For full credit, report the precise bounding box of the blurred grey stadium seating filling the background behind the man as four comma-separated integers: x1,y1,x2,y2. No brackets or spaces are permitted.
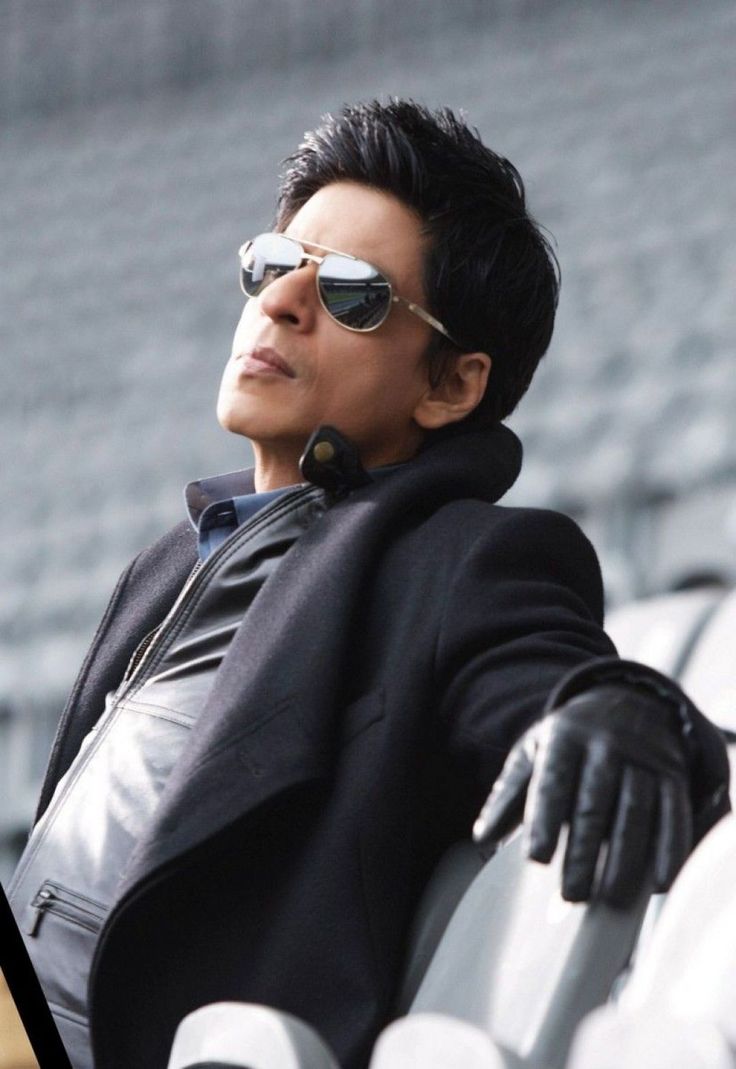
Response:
0,0,736,879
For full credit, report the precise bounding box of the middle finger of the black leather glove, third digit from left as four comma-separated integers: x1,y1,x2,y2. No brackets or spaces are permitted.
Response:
563,741,620,902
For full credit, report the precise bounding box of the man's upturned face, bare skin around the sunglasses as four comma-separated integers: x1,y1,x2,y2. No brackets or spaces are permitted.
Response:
217,182,431,481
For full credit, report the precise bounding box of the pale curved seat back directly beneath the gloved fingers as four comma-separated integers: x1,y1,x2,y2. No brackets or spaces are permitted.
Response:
402,833,648,1069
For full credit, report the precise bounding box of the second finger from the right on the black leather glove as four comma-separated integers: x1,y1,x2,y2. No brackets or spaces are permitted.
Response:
598,765,658,908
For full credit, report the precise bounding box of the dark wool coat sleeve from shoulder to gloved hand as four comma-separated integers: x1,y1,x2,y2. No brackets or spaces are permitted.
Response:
435,509,616,804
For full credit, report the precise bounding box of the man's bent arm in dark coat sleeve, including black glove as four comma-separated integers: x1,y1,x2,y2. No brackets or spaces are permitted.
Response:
438,510,729,904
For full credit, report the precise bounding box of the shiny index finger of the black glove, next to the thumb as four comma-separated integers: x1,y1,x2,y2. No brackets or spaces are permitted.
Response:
524,718,583,863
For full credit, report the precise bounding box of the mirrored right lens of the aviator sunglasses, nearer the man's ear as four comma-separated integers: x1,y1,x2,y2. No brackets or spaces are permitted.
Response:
317,253,392,330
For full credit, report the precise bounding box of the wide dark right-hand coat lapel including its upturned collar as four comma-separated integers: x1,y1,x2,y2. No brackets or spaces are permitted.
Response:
121,428,520,896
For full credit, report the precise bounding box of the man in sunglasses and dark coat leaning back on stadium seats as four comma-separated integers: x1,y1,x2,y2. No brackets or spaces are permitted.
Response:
7,100,726,1069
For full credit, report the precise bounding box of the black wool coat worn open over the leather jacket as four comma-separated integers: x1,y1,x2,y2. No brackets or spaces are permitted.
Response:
35,427,615,1069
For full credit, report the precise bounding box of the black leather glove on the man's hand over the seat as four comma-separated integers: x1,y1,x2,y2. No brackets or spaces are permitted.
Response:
473,662,729,907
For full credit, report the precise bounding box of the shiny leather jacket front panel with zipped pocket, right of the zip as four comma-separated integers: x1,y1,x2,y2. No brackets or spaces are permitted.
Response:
9,486,326,1069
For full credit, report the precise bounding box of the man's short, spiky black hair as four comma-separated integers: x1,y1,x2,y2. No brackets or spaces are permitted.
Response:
277,98,559,424
